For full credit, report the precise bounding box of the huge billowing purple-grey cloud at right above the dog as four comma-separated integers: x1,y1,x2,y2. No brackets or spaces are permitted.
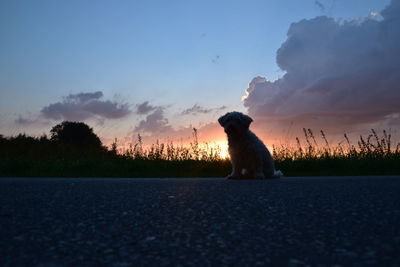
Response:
243,0,400,134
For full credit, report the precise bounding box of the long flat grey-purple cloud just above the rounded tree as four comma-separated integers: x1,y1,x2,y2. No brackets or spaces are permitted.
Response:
41,91,131,121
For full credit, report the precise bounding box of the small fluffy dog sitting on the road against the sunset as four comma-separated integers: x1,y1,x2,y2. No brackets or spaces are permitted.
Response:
218,111,283,179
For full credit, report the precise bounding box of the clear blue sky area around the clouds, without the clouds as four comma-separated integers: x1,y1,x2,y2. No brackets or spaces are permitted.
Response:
0,0,389,144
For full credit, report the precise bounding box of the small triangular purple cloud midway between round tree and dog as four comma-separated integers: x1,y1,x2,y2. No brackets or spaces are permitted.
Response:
135,108,173,135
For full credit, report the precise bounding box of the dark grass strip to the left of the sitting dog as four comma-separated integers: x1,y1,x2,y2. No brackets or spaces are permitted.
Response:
0,131,230,177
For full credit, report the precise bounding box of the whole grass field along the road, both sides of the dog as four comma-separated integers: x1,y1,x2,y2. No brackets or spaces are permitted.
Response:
0,129,400,177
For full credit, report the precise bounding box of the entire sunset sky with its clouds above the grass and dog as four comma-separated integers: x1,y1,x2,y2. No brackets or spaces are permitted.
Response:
0,0,400,151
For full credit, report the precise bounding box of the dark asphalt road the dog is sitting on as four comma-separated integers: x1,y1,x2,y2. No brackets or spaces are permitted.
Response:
0,177,400,266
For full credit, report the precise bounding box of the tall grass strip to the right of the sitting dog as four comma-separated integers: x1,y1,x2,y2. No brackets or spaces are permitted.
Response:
273,129,400,175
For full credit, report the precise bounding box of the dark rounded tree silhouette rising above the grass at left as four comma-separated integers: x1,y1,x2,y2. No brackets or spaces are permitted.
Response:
50,121,102,149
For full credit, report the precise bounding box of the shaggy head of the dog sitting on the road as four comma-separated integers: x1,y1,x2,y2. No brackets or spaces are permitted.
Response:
218,111,253,135
